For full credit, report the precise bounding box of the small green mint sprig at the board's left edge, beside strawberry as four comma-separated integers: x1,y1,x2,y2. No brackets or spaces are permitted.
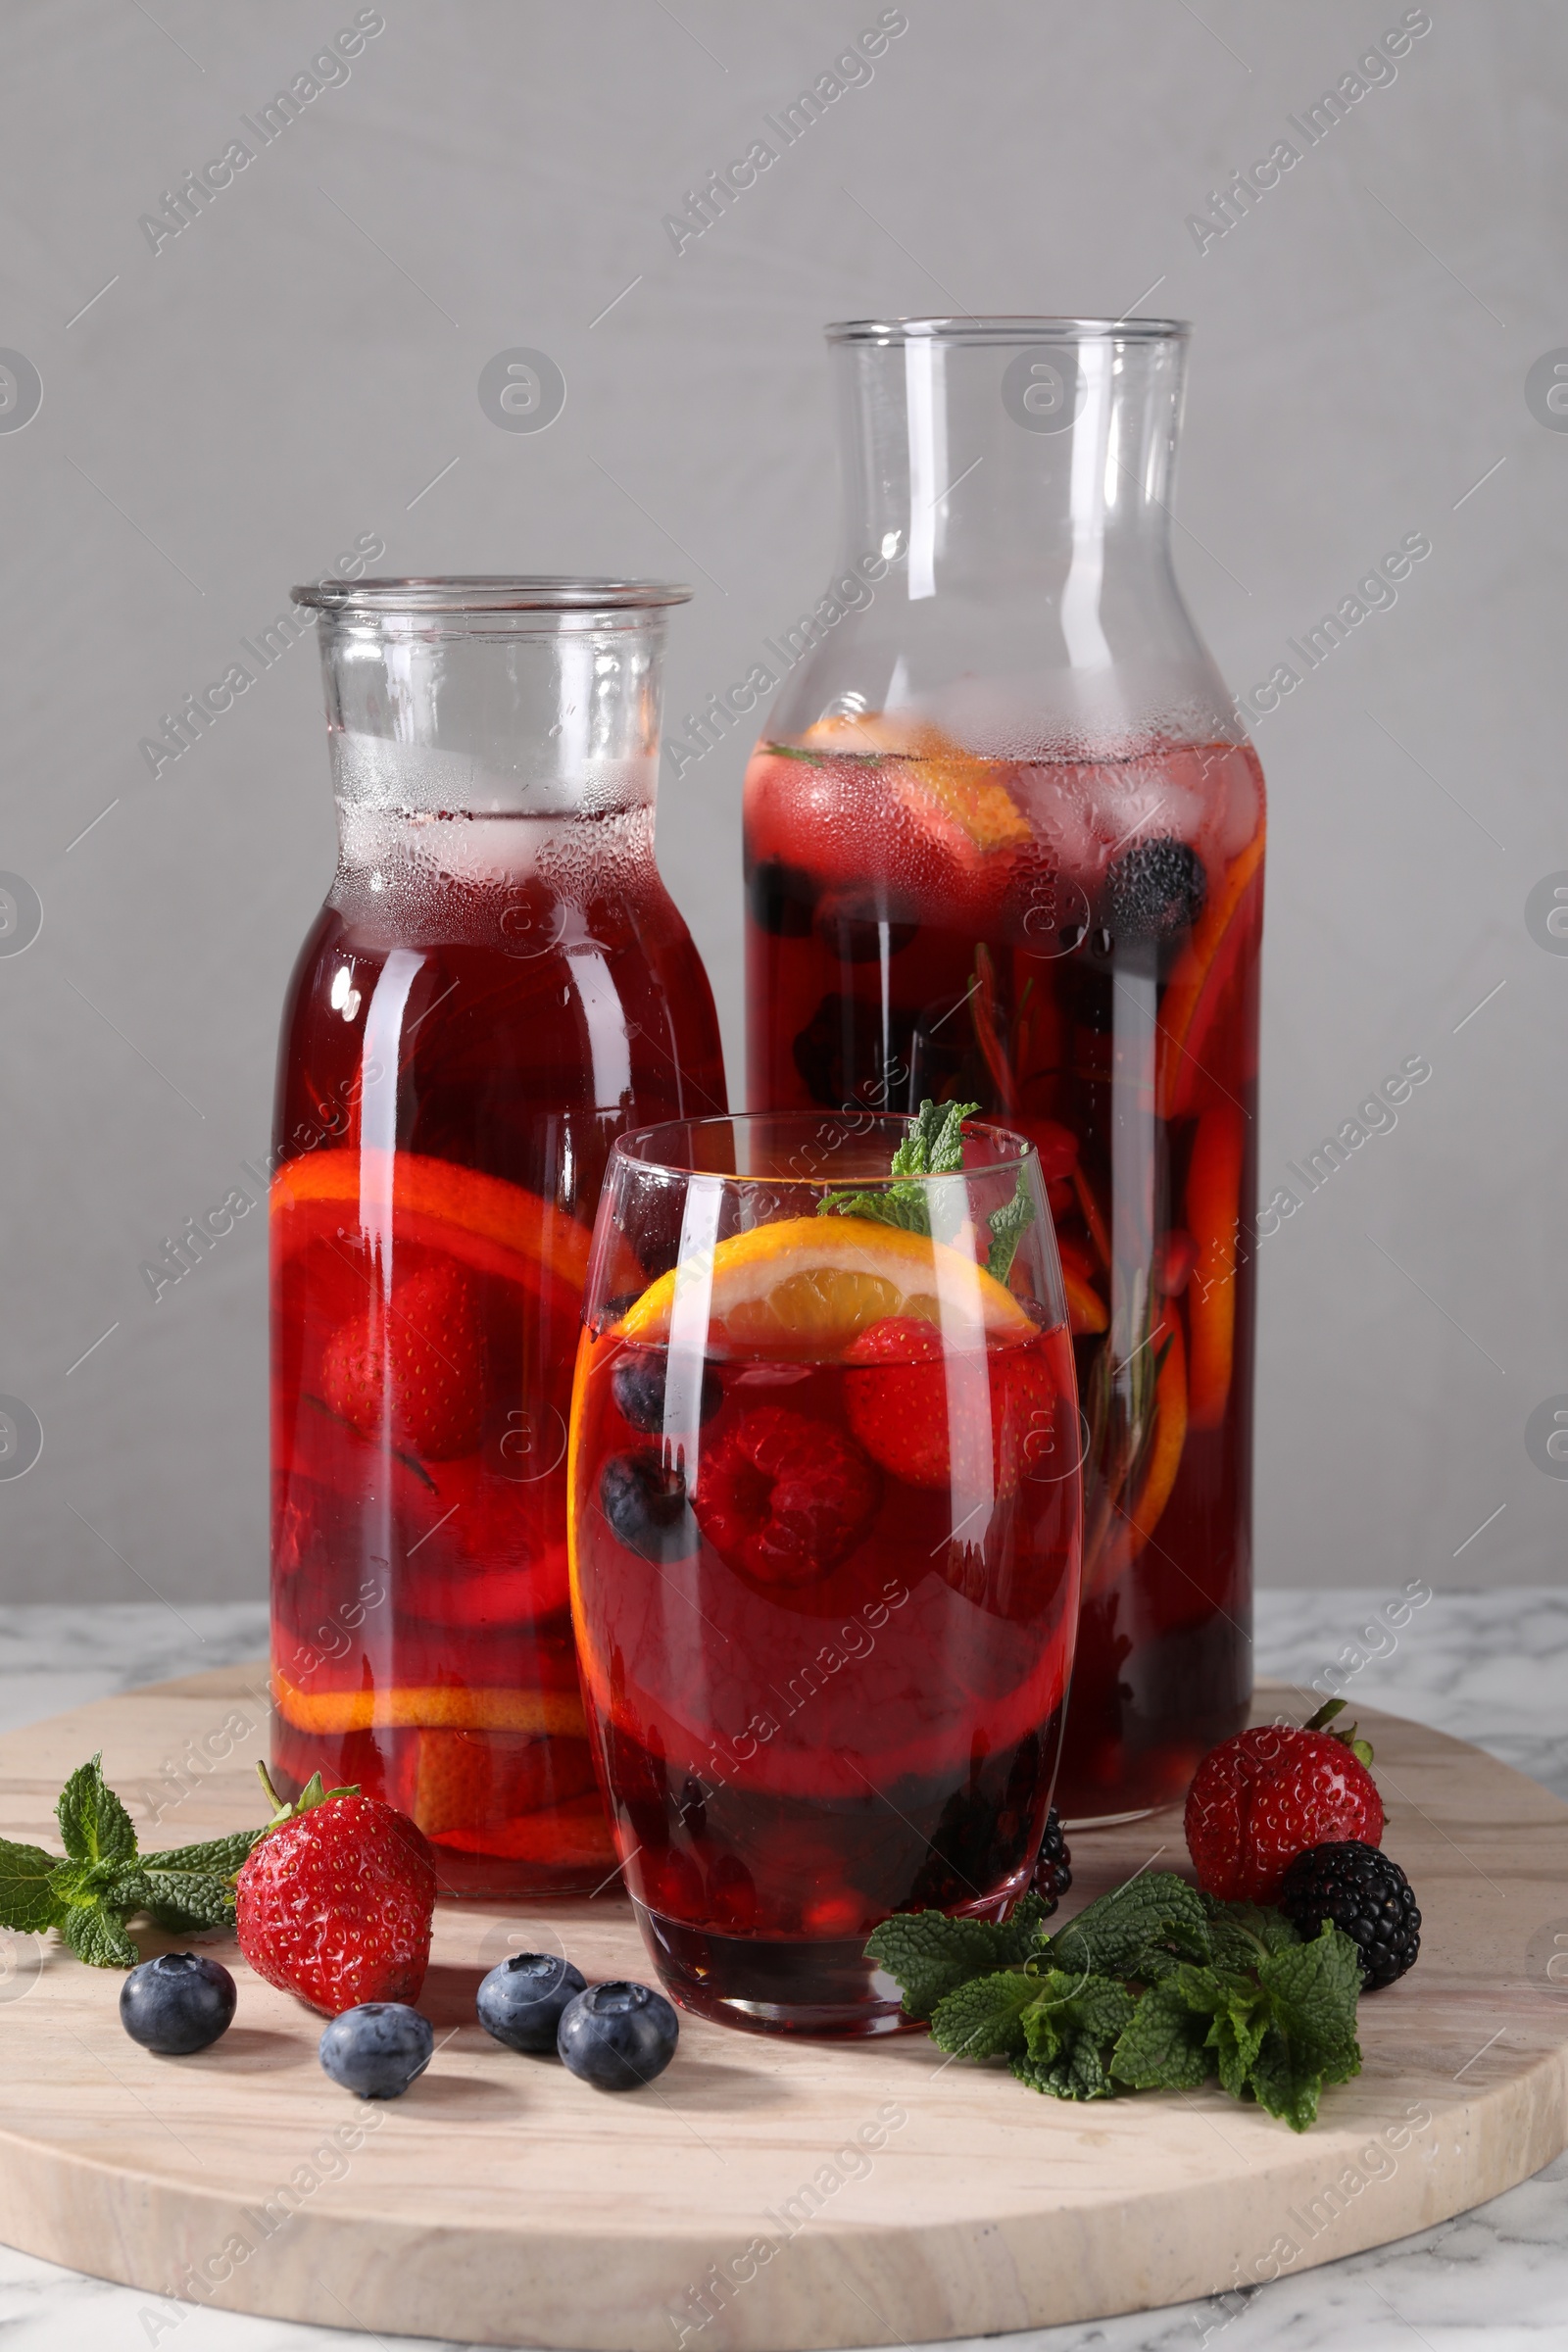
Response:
0,1754,266,1969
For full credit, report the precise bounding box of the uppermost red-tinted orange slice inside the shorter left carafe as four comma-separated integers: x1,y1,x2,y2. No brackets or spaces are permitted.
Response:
270,1148,590,1294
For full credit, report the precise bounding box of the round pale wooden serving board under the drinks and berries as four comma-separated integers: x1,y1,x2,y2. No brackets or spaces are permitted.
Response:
0,1668,1568,2352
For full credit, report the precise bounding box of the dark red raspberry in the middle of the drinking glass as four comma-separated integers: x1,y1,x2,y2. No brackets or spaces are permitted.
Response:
691,1404,882,1586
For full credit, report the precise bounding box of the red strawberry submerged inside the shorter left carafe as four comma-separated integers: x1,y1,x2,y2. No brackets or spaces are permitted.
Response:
322,1258,484,1463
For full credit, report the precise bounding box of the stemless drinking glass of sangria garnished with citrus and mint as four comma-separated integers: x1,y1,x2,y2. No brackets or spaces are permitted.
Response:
571,1105,1081,2034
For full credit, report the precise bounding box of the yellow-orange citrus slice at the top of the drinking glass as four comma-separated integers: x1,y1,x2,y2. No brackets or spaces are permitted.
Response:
620,1216,1034,1354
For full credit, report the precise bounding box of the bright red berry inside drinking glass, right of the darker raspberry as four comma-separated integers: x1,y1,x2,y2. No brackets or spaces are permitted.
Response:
844,1315,1057,1494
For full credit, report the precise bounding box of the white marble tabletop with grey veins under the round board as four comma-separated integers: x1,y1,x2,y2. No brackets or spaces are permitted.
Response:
0,1590,1568,2352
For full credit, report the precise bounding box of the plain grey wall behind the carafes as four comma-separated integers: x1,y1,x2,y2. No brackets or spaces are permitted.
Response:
0,0,1568,1601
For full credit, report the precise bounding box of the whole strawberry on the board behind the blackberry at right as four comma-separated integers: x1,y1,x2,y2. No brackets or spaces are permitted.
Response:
1187,1698,1382,1903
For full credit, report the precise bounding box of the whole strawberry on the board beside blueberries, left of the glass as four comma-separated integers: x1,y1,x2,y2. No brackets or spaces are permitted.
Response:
235,1764,435,2018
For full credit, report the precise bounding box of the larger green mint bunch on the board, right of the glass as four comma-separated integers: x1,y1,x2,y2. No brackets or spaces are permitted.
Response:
865,1870,1361,2131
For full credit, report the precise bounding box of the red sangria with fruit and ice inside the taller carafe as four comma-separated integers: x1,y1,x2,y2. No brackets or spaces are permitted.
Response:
748,719,1262,1818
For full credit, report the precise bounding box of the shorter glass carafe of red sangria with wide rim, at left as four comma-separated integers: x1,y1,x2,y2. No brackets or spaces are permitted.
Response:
270,578,724,1893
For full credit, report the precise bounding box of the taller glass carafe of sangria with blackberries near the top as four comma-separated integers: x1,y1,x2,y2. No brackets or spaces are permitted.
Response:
745,318,1265,1821
